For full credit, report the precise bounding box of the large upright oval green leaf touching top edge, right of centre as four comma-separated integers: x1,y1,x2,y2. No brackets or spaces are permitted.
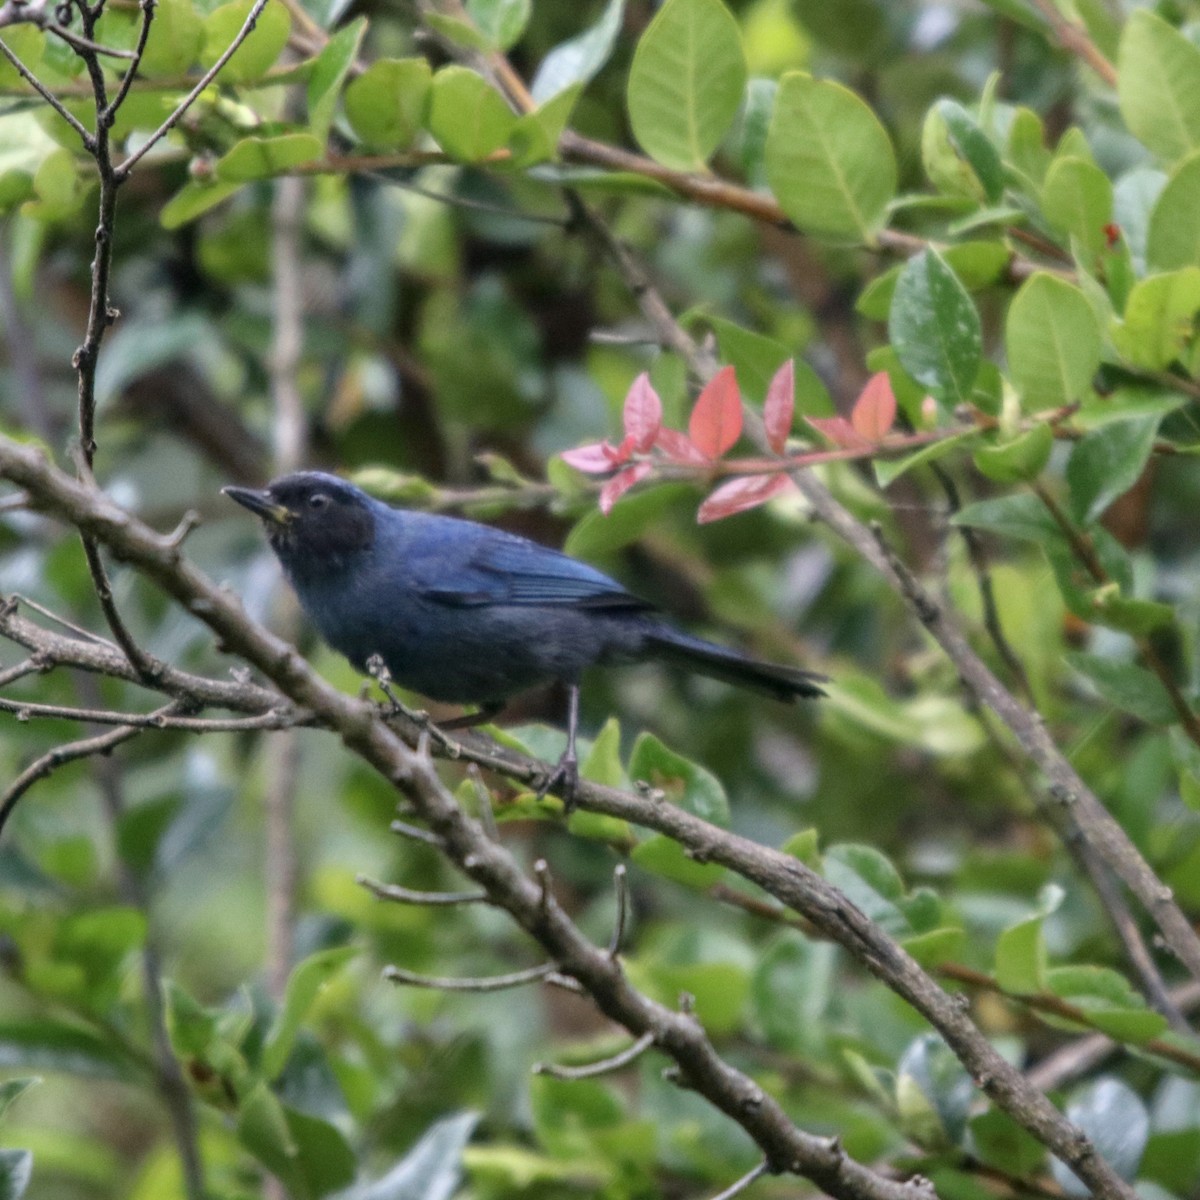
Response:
626,0,746,170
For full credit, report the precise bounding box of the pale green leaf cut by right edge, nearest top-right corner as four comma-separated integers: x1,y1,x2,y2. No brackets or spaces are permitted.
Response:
1117,8,1200,162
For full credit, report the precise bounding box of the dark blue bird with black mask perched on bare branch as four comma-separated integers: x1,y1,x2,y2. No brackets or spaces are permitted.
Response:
224,472,823,805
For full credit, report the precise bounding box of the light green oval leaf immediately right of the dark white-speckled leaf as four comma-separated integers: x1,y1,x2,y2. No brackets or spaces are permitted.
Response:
1004,271,1102,412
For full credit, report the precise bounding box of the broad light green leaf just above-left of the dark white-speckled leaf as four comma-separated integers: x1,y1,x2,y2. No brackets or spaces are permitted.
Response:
767,71,896,242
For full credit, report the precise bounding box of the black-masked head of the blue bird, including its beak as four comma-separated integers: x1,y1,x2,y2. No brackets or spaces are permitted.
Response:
222,470,374,574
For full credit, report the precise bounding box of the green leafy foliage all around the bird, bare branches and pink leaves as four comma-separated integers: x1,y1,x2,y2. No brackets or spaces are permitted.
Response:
0,0,1200,1200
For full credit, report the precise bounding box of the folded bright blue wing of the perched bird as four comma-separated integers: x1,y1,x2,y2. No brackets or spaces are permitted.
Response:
412,529,653,612
